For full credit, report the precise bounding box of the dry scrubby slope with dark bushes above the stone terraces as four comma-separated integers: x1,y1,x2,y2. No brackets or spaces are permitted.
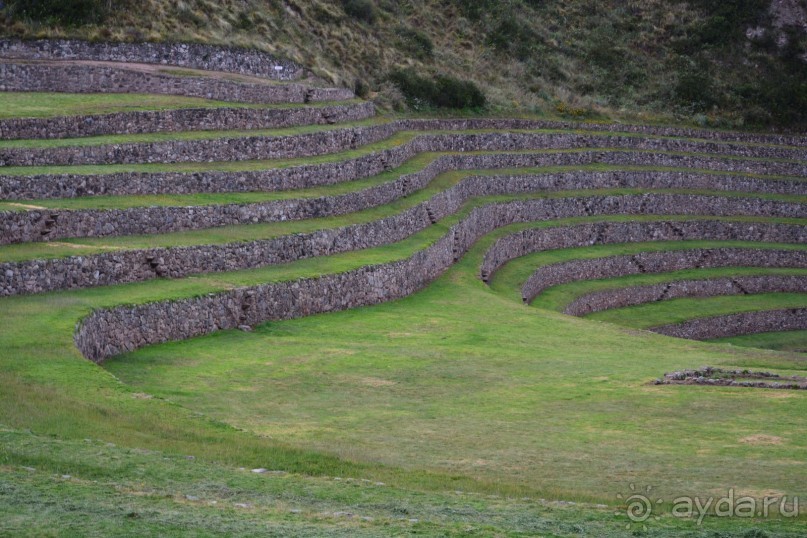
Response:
0,0,807,127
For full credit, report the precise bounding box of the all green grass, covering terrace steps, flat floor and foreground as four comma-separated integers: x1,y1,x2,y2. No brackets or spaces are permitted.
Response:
0,86,807,538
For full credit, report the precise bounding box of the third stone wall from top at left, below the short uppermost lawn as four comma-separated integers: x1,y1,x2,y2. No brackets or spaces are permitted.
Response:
0,101,375,140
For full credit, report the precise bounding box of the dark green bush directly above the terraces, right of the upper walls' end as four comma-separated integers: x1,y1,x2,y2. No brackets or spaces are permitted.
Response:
389,69,487,109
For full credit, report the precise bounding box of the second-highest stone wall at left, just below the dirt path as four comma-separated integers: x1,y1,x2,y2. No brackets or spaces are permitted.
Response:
0,58,355,107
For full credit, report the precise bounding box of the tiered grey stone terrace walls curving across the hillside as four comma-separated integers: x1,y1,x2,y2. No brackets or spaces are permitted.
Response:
0,41,807,362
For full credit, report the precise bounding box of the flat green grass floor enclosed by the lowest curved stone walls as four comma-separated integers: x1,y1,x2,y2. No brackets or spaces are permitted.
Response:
101,231,807,502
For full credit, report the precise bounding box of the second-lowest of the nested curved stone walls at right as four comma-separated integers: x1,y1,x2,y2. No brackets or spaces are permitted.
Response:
563,275,807,316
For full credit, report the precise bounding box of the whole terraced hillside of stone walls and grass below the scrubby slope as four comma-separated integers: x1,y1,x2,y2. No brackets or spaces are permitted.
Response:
0,42,807,536
